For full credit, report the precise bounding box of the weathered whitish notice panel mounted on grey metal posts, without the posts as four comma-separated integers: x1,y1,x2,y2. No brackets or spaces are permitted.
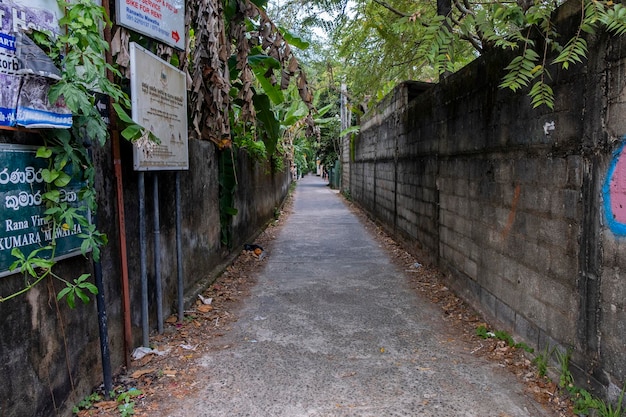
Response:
130,42,189,171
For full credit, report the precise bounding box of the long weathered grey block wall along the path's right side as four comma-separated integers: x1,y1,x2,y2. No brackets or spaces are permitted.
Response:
343,3,626,396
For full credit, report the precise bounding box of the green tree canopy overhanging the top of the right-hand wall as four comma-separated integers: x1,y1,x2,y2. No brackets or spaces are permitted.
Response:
275,0,626,107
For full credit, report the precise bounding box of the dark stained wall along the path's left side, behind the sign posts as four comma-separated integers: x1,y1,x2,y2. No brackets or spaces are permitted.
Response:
0,135,290,417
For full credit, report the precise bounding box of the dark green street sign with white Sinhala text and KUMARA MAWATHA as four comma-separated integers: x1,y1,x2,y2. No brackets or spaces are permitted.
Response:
0,145,84,277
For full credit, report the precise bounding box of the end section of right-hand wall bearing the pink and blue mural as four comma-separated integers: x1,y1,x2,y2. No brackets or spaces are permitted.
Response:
596,33,626,391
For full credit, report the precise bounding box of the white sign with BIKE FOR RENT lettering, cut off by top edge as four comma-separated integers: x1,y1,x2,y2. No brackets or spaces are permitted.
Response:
115,0,185,49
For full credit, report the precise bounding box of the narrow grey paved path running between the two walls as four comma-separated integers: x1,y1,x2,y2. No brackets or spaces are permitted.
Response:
164,176,551,417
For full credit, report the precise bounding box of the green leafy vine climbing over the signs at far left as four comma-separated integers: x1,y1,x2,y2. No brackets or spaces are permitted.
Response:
0,0,147,308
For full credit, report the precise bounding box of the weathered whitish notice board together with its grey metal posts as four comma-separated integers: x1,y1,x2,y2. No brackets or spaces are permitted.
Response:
130,42,189,346
